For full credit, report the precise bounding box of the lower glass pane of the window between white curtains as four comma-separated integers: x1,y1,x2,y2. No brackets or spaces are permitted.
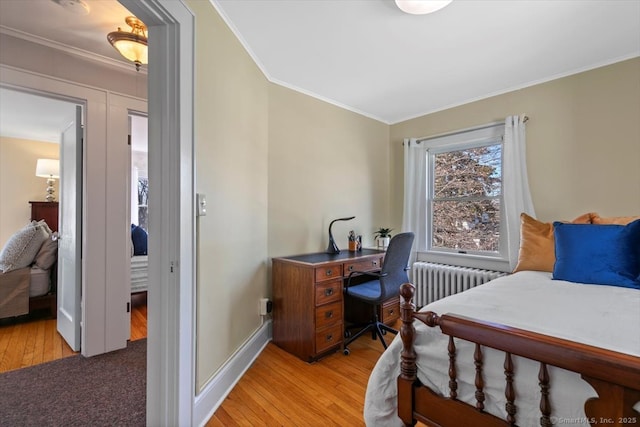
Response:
432,199,500,252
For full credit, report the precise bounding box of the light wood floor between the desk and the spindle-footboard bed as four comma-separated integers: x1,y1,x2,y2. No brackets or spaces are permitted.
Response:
206,324,394,427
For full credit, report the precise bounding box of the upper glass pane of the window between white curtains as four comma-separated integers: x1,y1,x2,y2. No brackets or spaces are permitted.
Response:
433,144,502,199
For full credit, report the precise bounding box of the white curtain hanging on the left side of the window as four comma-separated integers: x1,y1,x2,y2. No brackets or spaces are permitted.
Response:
402,138,428,263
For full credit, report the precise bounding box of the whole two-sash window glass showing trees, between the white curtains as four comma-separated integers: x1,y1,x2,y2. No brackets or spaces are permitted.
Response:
427,138,503,256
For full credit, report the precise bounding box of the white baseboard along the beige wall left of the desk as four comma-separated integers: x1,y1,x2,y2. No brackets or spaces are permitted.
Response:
193,319,272,427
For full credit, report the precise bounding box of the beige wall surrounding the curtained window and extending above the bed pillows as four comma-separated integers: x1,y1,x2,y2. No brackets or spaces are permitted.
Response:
389,58,640,225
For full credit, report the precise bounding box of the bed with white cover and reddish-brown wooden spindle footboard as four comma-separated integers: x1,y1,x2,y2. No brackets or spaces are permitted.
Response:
364,216,640,427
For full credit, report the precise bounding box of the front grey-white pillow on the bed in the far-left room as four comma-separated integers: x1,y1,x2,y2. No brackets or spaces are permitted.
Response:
0,224,49,273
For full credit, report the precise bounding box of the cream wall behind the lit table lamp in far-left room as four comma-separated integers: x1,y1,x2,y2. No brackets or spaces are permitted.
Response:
0,138,60,248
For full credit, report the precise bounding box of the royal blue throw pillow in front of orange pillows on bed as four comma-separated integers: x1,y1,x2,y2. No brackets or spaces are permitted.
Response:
553,220,640,289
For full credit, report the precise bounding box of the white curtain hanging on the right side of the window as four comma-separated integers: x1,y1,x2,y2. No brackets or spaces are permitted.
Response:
502,115,535,270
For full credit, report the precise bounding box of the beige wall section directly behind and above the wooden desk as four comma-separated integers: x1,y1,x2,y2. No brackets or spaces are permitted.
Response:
269,84,390,257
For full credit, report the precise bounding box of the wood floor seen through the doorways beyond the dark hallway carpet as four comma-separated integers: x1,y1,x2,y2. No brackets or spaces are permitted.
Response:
0,294,147,373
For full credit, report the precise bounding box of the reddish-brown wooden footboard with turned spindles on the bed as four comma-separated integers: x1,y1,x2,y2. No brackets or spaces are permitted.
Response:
398,283,640,427
